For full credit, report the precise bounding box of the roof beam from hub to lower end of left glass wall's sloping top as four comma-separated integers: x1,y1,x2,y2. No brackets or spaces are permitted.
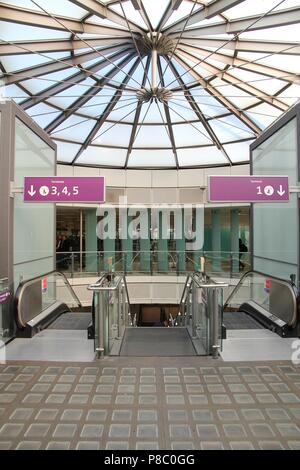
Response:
45,53,135,134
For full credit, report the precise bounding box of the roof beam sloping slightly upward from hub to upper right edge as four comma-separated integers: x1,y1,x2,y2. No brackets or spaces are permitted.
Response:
167,7,300,38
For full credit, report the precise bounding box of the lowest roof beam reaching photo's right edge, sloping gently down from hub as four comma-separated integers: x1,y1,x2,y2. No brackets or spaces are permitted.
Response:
181,44,300,82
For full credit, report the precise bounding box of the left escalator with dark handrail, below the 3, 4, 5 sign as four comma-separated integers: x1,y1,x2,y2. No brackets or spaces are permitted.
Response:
14,271,85,338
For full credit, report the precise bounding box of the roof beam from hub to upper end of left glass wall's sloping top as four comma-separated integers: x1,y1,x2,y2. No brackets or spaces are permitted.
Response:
21,49,132,109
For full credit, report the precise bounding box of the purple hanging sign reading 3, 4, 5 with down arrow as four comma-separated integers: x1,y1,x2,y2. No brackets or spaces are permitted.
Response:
24,176,105,203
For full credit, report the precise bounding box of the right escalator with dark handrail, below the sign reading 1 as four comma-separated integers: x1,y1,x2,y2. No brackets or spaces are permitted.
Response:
223,271,300,338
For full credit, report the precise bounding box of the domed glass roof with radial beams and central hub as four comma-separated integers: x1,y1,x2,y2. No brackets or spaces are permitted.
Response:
0,0,300,168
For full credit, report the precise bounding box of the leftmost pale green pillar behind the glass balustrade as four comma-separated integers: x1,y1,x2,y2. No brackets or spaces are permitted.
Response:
85,209,98,273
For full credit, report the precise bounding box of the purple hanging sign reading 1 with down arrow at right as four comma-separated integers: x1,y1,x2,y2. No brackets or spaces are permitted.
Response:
208,175,289,202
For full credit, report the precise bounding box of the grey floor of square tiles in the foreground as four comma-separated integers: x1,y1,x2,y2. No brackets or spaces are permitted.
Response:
0,357,300,450
